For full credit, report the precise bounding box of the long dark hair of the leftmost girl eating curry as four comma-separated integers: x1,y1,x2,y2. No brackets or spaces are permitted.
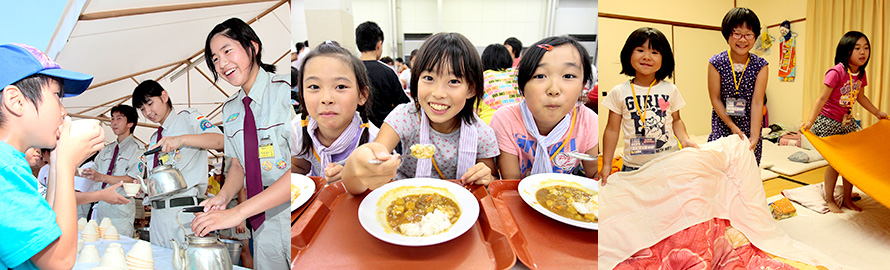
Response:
297,43,372,156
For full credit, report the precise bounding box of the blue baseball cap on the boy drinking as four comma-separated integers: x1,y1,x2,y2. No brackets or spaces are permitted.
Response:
0,43,93,97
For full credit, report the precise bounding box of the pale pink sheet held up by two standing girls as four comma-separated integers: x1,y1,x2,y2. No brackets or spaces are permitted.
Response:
598,136,844,269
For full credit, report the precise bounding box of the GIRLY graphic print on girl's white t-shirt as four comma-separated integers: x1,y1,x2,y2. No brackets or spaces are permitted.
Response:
624,94,671,148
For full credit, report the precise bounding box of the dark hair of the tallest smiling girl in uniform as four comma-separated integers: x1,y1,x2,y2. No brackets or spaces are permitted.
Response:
204,18,275,82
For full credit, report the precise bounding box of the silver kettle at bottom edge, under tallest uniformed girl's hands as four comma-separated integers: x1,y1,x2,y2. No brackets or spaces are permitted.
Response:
170,206,232,270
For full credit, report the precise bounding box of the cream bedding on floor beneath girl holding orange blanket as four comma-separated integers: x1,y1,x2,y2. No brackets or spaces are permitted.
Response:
767,189,890,269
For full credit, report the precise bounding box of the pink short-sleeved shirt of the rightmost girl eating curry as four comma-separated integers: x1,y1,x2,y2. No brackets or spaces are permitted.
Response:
491,104,599,177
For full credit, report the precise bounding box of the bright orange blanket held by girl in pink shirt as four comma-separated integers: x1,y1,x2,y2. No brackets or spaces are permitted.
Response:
800,120,890,207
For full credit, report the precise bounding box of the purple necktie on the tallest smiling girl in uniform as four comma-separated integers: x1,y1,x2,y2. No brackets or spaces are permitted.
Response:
241,97,266,230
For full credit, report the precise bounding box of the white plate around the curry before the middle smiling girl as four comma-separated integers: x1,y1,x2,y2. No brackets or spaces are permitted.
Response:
358,178,479,246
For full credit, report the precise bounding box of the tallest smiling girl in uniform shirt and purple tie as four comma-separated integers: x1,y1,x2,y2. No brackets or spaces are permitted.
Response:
191,18,294,269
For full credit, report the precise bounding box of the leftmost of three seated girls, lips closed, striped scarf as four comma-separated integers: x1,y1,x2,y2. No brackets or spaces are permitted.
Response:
291,43,378,182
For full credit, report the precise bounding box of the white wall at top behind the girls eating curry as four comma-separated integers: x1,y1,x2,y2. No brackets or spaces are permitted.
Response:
352,0,597,56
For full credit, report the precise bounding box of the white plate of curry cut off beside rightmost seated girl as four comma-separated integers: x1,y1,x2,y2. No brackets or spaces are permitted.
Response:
518,173,599,230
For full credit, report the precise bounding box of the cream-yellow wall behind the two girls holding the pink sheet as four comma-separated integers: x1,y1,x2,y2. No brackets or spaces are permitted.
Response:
599,0,812,142
